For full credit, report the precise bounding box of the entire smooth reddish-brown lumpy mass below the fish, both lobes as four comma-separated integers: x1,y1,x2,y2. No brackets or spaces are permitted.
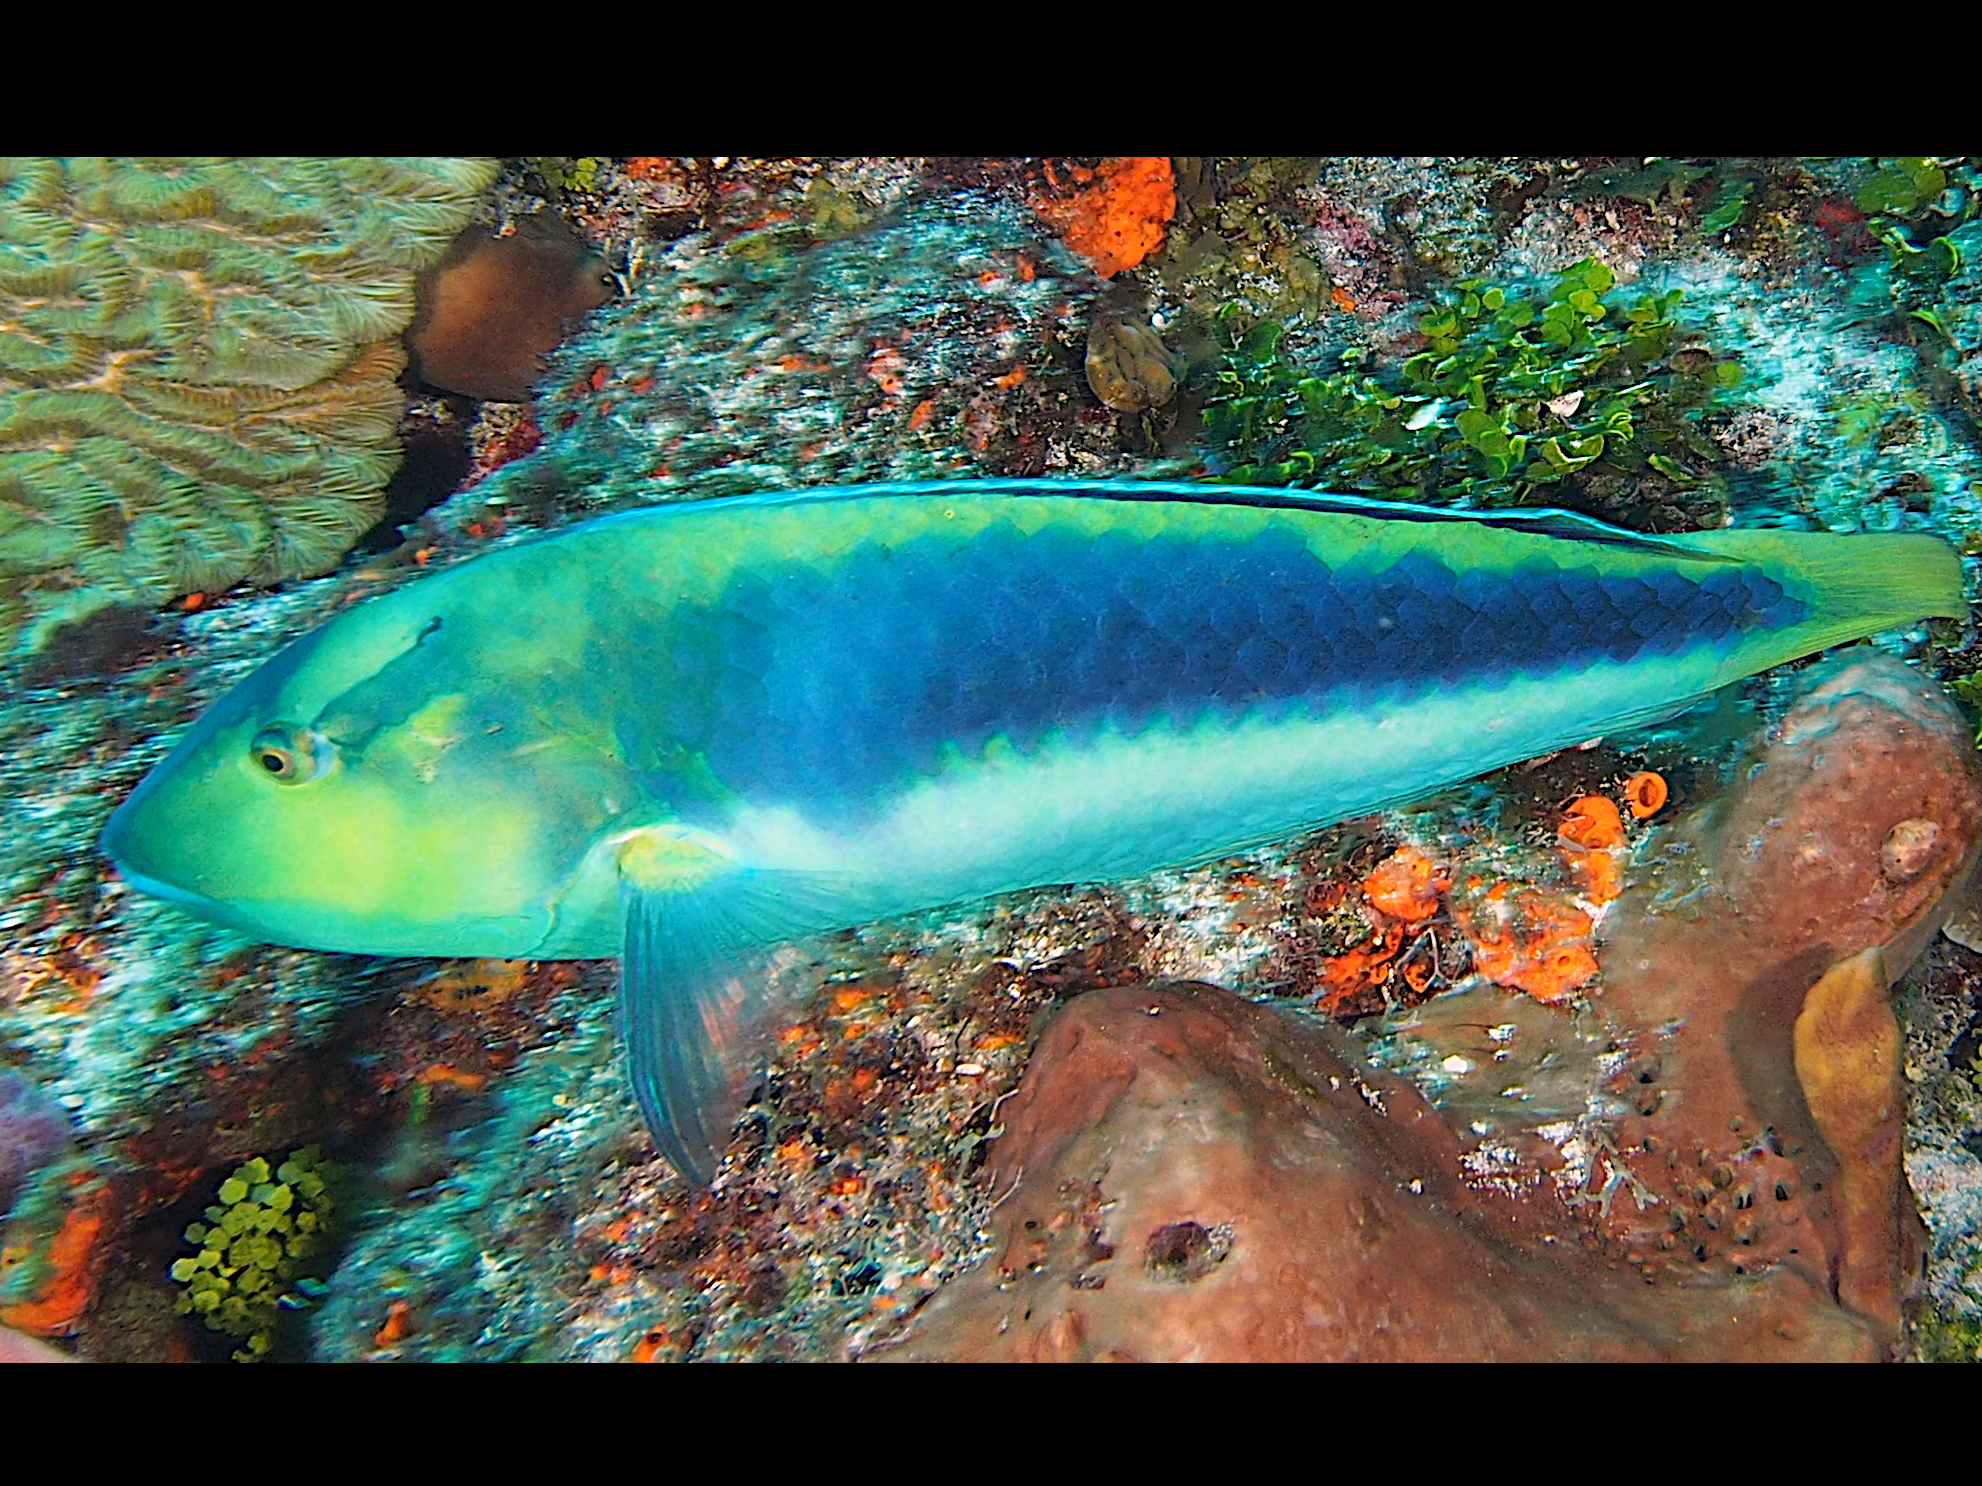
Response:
892,652,1982,1361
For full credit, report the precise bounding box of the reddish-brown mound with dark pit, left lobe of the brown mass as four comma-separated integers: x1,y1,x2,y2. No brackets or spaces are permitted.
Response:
894,985,1875,1361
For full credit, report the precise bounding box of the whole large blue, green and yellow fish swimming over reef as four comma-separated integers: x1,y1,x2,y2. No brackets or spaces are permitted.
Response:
103,479,1966,1181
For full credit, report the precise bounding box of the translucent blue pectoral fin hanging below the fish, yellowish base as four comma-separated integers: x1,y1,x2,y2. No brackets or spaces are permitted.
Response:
618,828,838,1187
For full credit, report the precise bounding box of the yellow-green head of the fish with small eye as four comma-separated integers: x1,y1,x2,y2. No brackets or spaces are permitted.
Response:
103,575,614,957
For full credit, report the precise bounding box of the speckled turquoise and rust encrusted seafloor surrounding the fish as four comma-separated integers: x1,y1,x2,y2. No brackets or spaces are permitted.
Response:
0,159,1982,1361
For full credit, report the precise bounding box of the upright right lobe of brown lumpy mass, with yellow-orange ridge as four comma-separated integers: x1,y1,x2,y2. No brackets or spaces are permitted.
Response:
1569,652,1982,1337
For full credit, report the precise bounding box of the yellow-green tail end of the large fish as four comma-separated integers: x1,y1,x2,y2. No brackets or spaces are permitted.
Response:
1677,531,1968,680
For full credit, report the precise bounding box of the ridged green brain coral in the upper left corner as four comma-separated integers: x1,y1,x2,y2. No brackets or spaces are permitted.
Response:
0,160,496,654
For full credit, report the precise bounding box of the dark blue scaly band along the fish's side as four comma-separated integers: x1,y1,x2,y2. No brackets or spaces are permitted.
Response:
668,527,1808,818
